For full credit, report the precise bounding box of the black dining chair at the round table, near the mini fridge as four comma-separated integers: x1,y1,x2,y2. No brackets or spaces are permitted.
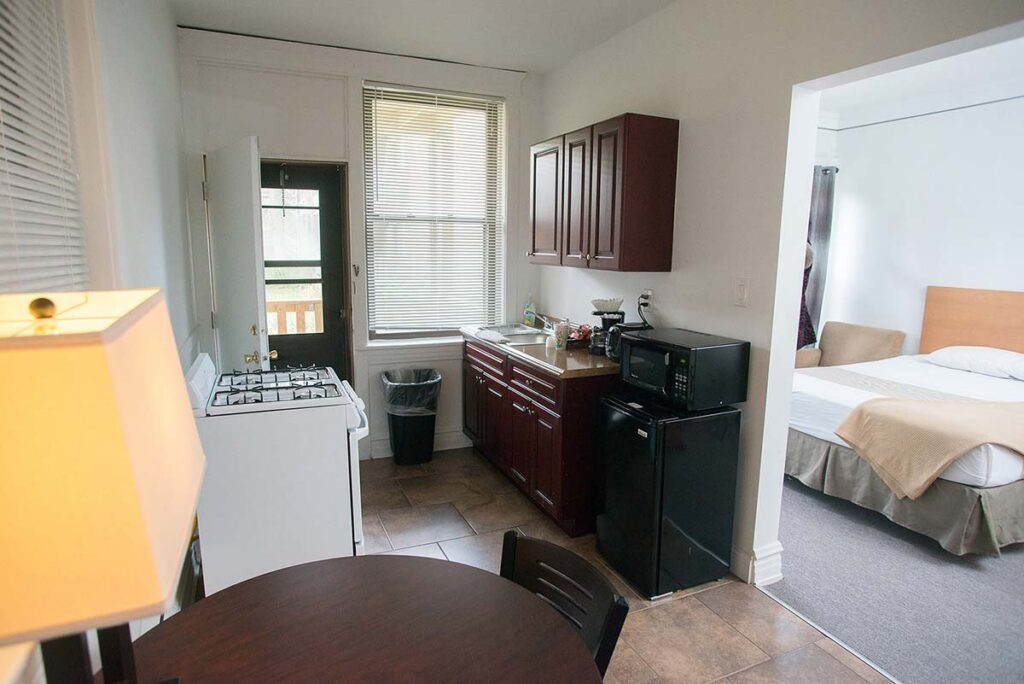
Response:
501,529,630,677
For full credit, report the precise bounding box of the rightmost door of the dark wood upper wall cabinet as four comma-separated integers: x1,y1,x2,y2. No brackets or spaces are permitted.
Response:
590,117,626,268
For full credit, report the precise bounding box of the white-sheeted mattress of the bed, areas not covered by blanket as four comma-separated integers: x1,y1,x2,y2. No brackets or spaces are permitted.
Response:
790,355,1024,487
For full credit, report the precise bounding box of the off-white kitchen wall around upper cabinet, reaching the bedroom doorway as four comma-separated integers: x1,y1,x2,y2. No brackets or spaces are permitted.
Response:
520,0,1024,582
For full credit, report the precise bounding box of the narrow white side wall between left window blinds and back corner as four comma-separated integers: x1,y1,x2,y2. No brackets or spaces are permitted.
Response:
95,0,197,366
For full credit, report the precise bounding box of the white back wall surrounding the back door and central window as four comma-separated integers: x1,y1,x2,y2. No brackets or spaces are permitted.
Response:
178,29,527,457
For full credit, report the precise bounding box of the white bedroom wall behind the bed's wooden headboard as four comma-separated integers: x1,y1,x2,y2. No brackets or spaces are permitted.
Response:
822,96,1024,353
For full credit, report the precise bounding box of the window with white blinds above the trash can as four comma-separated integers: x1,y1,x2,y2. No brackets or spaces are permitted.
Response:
362,85,505,338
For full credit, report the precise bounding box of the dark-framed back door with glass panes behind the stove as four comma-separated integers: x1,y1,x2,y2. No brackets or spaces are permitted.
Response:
260,161,351,380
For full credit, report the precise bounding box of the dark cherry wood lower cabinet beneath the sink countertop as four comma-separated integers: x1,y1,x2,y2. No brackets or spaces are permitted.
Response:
463,340,614,536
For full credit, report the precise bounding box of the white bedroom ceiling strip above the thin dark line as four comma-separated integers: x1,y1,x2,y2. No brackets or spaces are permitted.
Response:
821,39,1024,126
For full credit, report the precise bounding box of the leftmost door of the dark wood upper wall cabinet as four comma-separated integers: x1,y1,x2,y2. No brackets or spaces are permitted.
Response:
529,137,562,263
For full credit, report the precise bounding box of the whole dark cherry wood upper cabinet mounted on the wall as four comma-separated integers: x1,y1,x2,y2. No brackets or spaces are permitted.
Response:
530,114,679,271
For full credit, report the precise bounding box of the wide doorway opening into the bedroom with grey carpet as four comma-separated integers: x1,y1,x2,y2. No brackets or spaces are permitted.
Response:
763,25,1024,682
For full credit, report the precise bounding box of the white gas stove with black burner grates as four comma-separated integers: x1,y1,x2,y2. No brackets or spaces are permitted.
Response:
187,354,369,594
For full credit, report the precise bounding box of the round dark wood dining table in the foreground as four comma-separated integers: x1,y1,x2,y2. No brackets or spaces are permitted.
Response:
134,556,601,684
